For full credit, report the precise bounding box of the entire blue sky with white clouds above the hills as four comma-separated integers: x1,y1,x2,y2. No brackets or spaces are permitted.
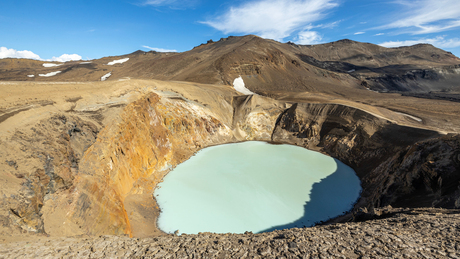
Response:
0,0,460,61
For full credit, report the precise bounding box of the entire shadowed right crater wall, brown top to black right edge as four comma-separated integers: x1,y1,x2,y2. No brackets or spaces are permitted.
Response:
272,104,460,220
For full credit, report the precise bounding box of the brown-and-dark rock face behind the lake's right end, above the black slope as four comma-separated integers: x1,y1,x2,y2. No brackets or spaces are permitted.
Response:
272,103,439,177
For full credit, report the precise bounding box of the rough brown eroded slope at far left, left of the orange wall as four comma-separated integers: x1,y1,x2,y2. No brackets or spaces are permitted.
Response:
1,115,99,232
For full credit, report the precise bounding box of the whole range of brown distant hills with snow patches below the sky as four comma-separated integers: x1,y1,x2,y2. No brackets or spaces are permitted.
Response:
0,35,460,98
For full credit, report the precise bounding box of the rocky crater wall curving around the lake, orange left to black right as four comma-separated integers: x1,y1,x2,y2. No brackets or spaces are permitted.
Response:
2,88,460,237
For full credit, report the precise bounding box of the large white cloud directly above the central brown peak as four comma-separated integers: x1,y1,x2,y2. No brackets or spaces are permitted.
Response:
202,0,338,40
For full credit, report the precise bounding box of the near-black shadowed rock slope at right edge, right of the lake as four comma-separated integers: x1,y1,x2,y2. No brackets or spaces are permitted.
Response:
363,135,460,208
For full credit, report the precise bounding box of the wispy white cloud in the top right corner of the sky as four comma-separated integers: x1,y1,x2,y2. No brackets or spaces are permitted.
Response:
379,0,460,34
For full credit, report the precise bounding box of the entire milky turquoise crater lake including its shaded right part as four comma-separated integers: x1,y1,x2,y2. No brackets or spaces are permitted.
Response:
154,141,361,234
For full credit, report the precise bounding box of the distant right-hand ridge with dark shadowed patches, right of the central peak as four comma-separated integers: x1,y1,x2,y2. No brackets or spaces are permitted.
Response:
296,40,460,96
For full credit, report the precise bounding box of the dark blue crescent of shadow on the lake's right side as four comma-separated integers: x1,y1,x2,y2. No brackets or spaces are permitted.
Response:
260,159,361,232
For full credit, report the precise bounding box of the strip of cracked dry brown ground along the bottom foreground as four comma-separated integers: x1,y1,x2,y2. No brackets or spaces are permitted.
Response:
0,209,460,258
